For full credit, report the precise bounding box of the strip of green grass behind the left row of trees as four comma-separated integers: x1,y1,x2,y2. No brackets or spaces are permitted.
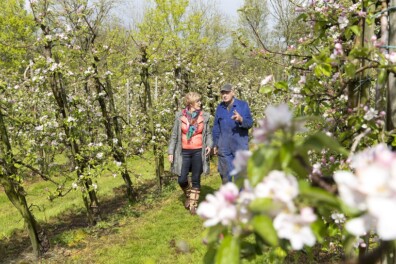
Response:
0,154,155,240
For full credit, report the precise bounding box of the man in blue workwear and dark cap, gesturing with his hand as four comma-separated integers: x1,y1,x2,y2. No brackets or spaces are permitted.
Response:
212,84,253,184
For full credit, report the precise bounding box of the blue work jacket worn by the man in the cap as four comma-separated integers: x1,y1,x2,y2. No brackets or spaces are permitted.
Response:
212,98,253,154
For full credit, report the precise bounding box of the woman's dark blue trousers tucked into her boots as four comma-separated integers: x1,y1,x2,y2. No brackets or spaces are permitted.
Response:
177,149,203,189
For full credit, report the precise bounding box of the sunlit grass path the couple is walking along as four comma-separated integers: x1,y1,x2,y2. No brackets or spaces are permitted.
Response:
45,176,220,263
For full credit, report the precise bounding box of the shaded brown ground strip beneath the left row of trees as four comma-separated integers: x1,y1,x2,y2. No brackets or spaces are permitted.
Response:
0,175,177,263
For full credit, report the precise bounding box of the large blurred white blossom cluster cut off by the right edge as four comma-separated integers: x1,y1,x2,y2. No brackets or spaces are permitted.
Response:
334,144,396,240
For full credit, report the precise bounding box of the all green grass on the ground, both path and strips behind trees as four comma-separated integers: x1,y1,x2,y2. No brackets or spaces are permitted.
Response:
0,155,276,264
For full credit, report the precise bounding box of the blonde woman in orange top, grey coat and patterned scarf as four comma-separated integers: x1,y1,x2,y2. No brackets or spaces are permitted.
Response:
168,92,212,214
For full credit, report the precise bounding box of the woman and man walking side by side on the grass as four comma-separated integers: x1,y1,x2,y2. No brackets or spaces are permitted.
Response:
168,84,253,214
